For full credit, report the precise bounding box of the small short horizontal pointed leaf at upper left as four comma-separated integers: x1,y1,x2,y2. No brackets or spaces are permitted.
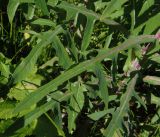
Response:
31,18,56,27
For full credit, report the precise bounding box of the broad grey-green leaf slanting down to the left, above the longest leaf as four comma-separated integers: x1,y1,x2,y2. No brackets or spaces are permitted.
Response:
13,26,62,83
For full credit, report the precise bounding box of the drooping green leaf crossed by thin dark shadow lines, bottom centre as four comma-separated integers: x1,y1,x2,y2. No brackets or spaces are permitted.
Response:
67,82,86,133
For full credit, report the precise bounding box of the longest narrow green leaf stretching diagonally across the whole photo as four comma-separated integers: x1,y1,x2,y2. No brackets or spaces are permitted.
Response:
15,35,155,113
